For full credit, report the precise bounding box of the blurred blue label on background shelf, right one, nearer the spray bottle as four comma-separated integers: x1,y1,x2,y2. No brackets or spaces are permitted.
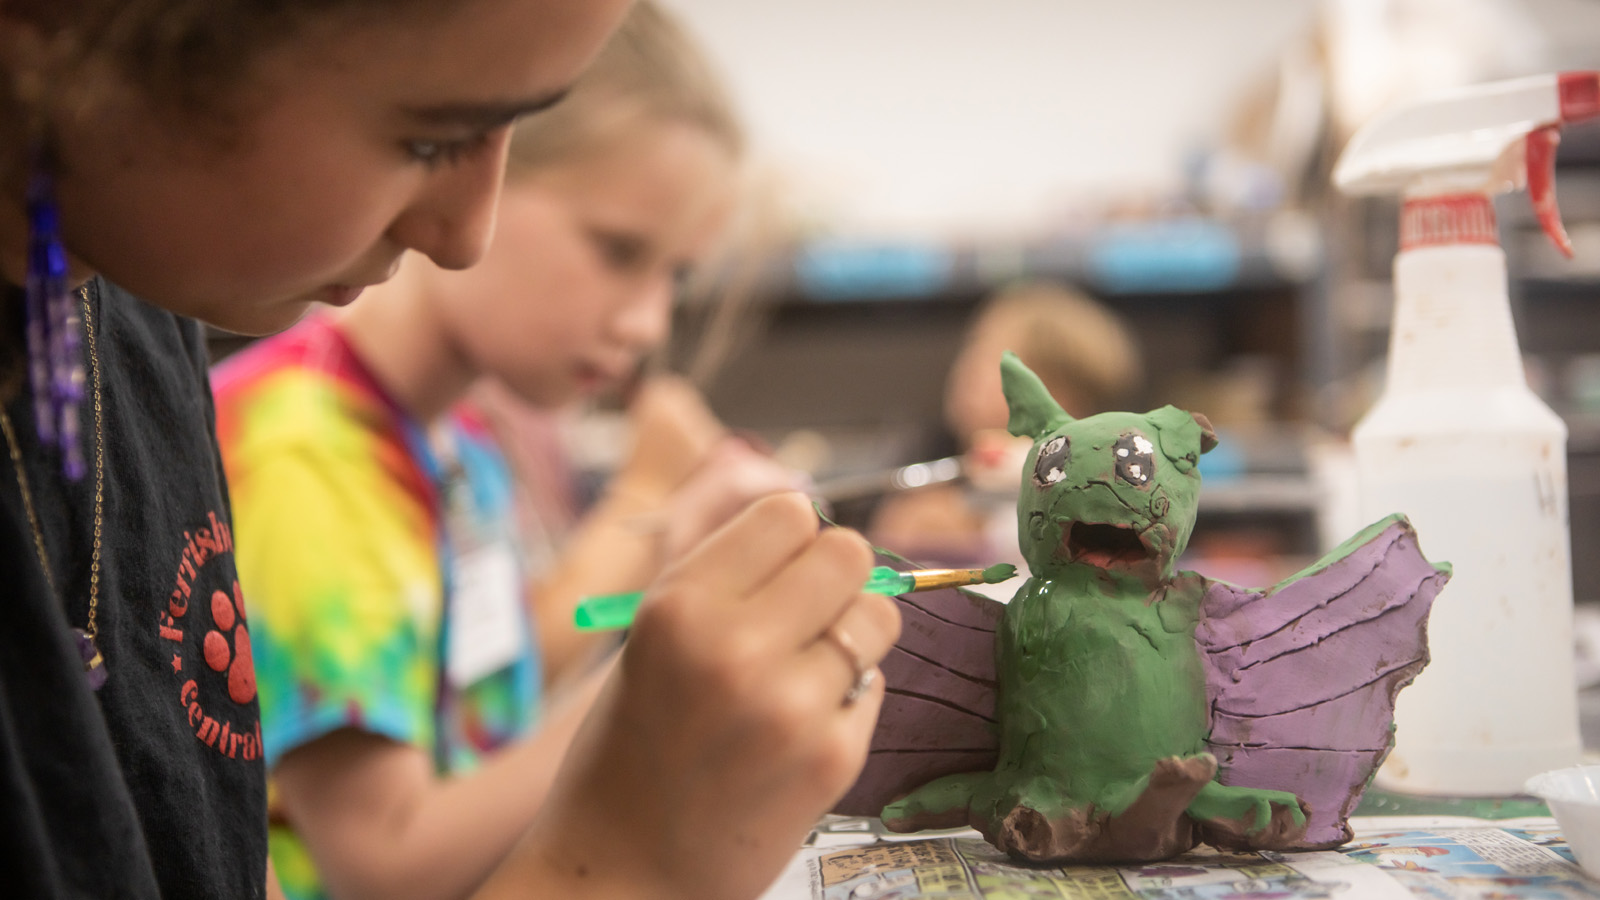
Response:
1088,219,1240,293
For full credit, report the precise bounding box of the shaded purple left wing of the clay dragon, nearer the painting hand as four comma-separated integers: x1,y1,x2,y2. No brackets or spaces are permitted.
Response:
834,573,1005,817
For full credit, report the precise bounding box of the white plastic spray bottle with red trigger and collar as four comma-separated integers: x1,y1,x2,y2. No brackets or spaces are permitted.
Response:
1334,72,1600,796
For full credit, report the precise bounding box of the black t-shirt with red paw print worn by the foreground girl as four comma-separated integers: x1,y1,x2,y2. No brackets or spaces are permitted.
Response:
0,279,267,900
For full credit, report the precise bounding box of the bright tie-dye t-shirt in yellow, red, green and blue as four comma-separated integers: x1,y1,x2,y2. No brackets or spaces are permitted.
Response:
211,319,539,900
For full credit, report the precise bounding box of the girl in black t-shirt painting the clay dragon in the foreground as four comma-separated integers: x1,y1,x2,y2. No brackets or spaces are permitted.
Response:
0,0,898,900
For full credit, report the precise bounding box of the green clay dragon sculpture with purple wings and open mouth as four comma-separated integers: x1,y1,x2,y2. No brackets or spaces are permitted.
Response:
838,354,1450,863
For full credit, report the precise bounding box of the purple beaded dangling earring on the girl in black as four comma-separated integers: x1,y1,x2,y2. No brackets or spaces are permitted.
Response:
24,151,88,480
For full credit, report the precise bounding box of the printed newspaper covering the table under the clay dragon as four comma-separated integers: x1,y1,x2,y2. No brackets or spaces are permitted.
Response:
765,817,1600,900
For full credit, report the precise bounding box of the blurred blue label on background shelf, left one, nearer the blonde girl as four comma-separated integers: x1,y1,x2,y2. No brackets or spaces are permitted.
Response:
795,242,954,299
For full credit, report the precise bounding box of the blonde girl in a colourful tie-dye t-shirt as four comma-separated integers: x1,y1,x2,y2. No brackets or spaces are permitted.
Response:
214,2,832,898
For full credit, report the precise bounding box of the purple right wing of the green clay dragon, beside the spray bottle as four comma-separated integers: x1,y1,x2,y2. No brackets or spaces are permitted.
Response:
1195,516,1450,847
